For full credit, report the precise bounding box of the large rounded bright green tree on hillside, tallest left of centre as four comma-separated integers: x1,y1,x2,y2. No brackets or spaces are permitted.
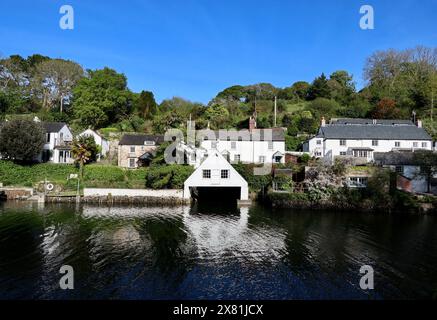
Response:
73,68,132,128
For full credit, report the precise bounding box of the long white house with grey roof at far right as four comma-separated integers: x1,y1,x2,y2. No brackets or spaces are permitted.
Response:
303,118,432,163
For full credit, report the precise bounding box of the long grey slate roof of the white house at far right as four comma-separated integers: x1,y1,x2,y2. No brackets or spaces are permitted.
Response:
317,119,432,141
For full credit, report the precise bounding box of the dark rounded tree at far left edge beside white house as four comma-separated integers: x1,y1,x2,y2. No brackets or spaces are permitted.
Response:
0,120,45,162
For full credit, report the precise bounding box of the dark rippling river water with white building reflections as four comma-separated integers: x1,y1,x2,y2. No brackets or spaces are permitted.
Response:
0,202,437,299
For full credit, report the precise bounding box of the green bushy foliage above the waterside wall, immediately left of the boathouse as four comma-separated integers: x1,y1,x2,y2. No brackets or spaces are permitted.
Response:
146,165,194,189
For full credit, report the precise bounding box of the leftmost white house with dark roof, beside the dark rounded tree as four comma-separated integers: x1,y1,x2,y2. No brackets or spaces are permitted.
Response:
37,122,74,163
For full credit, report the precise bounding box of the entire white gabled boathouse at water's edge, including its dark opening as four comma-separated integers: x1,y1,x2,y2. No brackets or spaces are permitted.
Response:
184,150,249,201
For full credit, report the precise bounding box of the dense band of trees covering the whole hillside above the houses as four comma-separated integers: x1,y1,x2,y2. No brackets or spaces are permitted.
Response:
0,47,437,148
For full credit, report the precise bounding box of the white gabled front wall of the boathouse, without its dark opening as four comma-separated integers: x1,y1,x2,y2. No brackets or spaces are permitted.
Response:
184,150,249,201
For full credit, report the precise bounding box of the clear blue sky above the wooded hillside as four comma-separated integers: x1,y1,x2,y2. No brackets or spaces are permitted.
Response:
0,0,437,103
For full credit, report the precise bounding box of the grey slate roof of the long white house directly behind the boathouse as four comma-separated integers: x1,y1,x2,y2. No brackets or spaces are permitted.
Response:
200,128,285,141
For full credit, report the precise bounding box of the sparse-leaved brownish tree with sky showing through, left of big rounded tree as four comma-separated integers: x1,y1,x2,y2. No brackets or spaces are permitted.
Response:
33,58,84,113
